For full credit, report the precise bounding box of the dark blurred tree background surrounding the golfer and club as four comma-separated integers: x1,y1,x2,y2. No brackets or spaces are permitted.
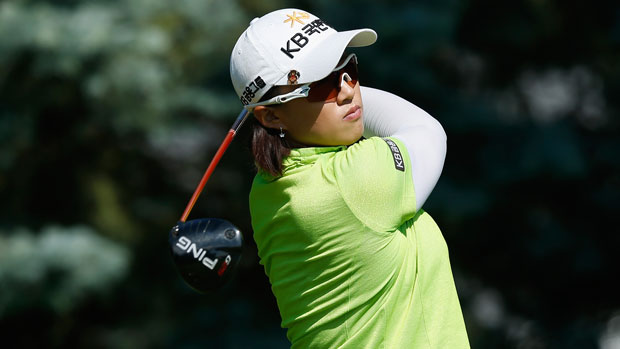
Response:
0,0,620,349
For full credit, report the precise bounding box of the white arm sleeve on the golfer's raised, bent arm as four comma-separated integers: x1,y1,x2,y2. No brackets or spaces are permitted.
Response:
361,87,446,210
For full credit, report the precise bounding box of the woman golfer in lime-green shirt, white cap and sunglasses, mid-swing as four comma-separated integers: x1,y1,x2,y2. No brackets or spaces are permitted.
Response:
230,9,469,349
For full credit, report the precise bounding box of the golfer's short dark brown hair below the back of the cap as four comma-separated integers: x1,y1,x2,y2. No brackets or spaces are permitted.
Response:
250,86,291,177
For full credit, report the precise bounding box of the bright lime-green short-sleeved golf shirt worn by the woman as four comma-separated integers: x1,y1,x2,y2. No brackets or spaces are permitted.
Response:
250,137,469,349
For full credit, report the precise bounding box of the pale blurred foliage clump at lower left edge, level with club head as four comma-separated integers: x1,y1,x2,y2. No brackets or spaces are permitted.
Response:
0,226,129,317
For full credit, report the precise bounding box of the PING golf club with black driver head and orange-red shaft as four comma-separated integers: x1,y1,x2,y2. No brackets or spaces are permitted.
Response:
168,108,249,293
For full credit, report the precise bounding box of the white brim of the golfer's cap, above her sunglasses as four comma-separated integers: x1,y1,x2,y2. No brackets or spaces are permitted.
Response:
275,29,377,85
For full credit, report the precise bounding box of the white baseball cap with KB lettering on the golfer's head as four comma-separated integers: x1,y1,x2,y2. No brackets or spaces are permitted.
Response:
230,9,377,105
